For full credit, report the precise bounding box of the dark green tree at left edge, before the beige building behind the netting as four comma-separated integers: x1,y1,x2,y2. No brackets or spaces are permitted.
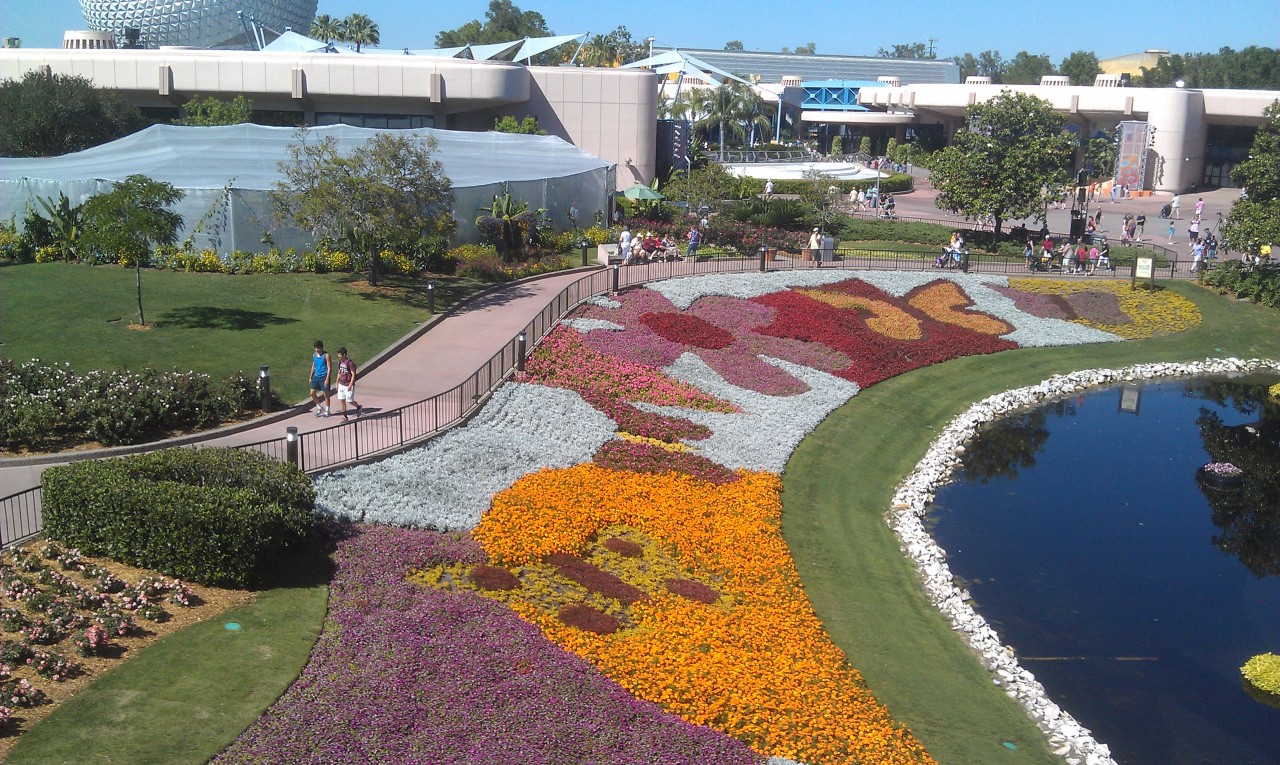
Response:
0,70,147,157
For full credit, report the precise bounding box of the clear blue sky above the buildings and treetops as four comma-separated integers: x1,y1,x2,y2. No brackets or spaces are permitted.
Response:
0,0,1280,64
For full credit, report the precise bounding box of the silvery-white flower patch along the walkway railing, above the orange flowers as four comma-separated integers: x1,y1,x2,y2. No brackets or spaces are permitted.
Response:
315,383,617,531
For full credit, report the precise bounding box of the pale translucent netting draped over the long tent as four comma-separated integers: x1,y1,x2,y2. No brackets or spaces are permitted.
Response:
0,124,614,253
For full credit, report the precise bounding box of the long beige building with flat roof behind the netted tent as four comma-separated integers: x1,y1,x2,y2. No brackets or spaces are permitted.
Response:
0,47,658,182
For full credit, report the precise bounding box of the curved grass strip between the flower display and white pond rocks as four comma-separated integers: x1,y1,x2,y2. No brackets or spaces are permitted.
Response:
782,283,1280,765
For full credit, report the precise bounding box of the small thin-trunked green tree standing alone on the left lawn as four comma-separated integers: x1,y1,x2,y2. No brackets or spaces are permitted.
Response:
81,175,186,325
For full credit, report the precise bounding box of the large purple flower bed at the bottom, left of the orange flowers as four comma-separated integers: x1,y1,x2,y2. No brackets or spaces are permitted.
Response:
214,526,764,765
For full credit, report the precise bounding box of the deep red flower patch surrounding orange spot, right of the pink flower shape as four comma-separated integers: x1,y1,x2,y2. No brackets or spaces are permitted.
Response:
753,280,1018,388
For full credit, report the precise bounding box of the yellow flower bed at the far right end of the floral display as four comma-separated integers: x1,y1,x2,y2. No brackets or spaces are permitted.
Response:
1009,279,1202,340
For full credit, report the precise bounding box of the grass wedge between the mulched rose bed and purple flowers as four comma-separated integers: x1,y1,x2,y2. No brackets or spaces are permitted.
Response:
6,558,328,765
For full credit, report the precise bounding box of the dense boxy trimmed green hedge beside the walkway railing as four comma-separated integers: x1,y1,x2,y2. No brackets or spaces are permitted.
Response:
41,449,315,586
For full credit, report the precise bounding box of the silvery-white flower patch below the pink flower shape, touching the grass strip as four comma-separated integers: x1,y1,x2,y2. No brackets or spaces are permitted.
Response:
636,353,859,473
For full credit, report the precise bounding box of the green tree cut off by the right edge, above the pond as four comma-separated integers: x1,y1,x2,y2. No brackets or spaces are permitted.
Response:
1222,101,1280,255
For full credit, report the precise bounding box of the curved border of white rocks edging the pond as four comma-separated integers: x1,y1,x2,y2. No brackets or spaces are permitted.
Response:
886,358,1280,765
